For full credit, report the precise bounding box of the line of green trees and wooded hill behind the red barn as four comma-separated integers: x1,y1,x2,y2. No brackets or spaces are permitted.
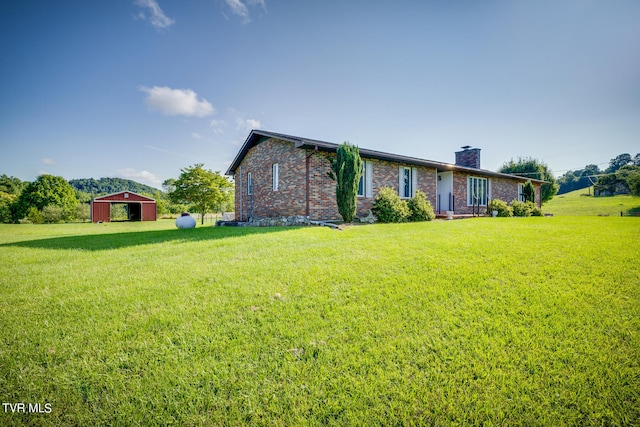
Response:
0,164,233,224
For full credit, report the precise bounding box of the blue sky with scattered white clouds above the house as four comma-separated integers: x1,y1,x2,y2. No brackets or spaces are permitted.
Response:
0,0,640,188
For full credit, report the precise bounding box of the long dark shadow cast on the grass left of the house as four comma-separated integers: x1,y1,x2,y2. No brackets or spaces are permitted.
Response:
0,227,290,251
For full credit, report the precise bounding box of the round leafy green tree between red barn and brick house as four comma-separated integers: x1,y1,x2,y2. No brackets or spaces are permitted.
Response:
169,163,233,224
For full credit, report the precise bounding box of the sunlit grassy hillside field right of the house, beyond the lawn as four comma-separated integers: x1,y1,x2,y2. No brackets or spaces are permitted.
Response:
542,187,640,216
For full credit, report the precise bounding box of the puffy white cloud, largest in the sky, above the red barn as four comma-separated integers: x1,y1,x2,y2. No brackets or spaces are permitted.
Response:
140,86,215,117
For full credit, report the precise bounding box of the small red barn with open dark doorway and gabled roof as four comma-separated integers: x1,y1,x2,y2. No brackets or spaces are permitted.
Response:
91,191,157,222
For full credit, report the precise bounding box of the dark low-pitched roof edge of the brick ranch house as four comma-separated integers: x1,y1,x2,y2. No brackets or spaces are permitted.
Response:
226,130,546,184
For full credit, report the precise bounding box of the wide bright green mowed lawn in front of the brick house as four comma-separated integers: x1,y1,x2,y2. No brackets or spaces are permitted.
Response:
0,217,640,426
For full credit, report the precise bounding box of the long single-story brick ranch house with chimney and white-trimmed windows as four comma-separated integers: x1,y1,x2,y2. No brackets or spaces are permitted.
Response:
226,130,544,221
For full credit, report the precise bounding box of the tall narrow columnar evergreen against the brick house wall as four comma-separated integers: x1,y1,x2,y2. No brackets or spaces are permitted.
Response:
329,141,362,222
